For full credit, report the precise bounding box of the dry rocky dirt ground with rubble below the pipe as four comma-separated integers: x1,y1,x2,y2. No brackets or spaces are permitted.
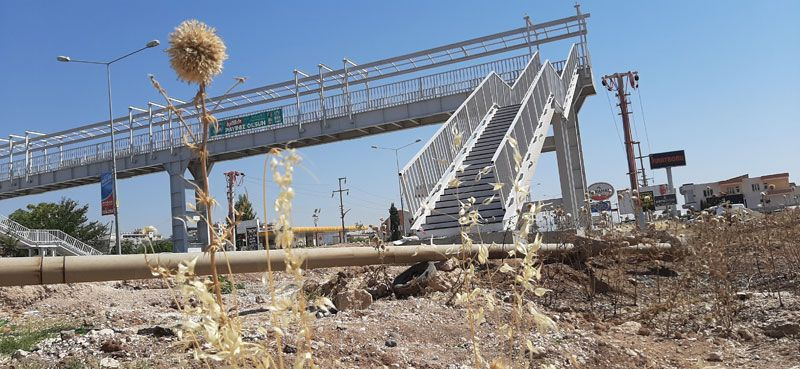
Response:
0,214,800,369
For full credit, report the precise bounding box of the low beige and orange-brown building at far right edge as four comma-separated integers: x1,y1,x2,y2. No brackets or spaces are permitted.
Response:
680,173,800,211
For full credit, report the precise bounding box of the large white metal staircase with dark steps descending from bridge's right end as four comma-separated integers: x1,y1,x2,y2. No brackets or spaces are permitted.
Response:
400,43,594,237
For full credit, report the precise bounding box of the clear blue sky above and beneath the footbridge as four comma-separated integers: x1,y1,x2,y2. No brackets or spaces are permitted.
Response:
0,1,800,233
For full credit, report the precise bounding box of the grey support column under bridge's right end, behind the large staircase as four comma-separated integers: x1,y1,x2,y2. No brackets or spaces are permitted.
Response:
553,115,591,232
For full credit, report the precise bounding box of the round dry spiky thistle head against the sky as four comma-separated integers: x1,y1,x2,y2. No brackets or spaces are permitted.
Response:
167,19,228,84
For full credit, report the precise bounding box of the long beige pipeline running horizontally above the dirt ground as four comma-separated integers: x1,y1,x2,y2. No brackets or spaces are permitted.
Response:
0,244,669,286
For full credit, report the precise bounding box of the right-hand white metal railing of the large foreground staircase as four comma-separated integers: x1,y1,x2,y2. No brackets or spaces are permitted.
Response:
492,45,580,220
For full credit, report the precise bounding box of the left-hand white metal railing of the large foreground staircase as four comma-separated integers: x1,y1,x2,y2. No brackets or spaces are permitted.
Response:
399,52,540,219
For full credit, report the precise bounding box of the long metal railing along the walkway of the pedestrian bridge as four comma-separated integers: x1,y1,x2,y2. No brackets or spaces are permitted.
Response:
0,55,528,180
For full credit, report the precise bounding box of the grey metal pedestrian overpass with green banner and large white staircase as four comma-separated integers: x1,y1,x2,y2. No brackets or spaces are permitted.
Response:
0,7,594,255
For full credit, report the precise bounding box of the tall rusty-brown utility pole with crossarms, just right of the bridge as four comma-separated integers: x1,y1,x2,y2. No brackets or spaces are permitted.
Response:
602,71,647,229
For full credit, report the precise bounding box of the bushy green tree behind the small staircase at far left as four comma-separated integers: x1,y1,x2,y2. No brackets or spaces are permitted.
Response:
8,198,109,244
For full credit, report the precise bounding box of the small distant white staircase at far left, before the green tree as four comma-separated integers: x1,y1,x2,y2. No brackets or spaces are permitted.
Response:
0,215,103,256
